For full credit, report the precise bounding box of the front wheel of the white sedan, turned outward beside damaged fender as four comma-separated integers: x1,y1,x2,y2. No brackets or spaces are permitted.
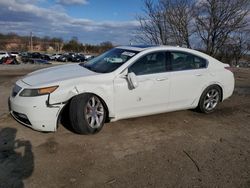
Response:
69,93,106,134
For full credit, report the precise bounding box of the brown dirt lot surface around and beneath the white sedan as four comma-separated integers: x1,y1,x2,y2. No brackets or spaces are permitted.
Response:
0,66,250,188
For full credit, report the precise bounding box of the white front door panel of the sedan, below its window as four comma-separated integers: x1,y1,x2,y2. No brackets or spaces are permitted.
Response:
114,73,170,119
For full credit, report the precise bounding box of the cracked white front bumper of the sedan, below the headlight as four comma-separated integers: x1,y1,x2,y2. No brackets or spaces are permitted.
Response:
9,81,63,132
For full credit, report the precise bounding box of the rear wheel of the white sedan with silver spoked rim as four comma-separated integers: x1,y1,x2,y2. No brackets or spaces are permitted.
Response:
198,85,222,113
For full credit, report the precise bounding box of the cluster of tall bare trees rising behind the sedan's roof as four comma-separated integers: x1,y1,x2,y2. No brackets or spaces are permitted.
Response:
137,0,250,64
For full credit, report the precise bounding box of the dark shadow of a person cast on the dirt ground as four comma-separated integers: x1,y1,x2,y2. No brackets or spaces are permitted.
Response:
0,128,34,188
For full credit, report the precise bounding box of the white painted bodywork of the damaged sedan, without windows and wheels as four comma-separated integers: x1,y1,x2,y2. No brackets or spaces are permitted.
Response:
10,46,234,131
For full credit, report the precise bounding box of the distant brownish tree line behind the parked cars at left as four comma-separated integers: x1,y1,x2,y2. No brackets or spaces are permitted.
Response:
0,33,113,54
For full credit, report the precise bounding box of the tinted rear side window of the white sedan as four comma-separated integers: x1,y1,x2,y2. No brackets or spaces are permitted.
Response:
170,52,207,71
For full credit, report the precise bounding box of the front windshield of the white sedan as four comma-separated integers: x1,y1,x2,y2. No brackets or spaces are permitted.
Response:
80,48,138,73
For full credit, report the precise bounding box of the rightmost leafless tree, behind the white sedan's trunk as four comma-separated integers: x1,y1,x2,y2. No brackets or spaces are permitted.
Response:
194,0,249,55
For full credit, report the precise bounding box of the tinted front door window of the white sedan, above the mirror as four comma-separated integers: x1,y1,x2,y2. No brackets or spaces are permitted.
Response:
129,52,166,75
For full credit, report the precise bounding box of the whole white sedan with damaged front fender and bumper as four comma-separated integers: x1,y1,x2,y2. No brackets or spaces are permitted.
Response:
9,46,234,134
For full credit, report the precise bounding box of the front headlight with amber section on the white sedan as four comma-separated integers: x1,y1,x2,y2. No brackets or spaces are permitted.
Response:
19,86,58,97
